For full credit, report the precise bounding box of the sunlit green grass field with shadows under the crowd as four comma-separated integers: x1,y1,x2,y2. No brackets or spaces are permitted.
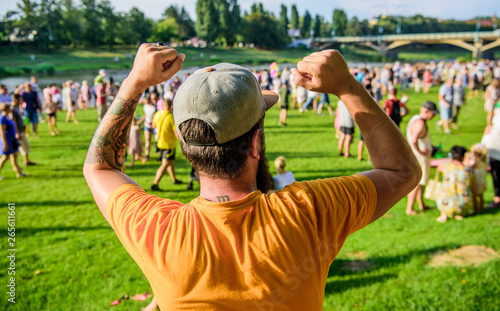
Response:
0,84,500,311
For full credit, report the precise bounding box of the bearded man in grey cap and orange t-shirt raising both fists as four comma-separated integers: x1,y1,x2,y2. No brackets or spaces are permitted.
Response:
84,43,421,311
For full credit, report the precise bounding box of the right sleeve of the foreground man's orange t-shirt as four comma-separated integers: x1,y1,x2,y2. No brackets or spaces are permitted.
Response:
290,175,377,260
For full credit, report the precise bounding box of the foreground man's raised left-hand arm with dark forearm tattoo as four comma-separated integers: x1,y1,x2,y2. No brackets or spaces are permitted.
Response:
83,43,185,224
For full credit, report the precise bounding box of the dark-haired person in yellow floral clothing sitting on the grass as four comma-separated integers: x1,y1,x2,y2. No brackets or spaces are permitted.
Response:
436,146,472,222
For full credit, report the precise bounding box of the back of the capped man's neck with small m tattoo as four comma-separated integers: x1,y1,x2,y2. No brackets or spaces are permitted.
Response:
200,174,257,202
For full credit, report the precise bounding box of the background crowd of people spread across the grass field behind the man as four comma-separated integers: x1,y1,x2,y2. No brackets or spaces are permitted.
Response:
0,60,500,220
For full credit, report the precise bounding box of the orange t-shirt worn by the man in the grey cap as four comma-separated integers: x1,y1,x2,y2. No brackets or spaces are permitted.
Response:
107,175,377,311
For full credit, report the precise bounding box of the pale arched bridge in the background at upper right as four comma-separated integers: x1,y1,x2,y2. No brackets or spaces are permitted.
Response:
312,29,500,58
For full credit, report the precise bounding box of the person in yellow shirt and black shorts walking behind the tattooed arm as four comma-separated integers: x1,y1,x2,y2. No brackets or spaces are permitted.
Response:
151,98,182,191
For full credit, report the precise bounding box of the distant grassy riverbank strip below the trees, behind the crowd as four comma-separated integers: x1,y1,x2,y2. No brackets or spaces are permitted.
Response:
0,46,492,78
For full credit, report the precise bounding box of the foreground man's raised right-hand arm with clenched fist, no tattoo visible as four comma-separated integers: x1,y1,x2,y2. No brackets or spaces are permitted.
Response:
293,50,422,221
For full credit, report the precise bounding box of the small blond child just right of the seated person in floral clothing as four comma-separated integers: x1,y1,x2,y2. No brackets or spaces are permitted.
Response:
466,144,488,213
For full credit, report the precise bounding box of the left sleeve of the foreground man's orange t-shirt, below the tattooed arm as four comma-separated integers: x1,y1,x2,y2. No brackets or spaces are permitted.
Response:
106,184,183,262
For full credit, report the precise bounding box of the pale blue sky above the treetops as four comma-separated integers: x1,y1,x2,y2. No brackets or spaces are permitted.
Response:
0,0,500,22
